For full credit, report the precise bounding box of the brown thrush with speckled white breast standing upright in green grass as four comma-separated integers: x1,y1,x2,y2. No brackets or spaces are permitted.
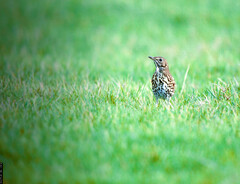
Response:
148,56,176,106
